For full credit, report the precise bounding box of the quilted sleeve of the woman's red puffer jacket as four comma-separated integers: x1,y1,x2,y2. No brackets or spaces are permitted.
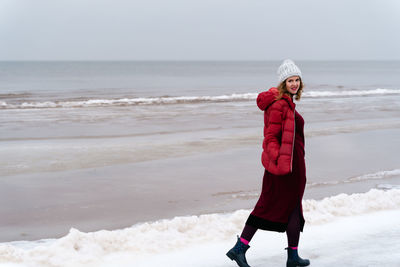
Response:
265,101,283,161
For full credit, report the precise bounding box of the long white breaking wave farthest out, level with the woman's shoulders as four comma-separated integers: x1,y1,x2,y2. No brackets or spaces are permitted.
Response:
0,88,400,109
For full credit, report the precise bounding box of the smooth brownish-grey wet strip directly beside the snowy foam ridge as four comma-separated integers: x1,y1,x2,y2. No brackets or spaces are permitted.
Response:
0,129,400,242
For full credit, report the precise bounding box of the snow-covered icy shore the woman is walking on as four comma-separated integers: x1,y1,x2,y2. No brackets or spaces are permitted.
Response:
0,189,400,267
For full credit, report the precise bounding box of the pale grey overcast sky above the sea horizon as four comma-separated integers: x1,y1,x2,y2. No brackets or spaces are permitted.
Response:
0,0,400,60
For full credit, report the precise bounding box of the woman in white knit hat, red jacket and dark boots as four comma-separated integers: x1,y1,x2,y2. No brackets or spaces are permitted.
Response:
226,60,310,267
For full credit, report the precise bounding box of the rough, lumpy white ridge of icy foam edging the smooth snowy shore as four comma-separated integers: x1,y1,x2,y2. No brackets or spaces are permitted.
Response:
0,189,400,266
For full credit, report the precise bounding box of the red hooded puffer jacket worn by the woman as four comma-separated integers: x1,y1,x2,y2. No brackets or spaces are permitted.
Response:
257,87,296,175
